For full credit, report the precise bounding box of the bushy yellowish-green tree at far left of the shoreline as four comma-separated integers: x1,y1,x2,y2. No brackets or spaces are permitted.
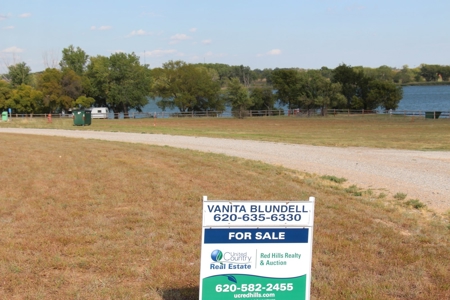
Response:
6,84,43,114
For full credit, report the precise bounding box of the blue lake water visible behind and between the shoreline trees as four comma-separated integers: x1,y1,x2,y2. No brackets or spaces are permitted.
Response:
130,85,450,115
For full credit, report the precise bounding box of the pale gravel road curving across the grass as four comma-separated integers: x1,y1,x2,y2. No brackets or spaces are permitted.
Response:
0,128,450,212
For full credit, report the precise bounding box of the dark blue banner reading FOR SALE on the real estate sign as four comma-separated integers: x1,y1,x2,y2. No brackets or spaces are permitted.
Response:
204,228,309,244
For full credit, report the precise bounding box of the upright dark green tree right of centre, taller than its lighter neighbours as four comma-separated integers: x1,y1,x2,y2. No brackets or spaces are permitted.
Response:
272,69,301,109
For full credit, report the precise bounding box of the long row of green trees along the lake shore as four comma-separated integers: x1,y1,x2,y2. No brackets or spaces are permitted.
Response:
0,45,450,117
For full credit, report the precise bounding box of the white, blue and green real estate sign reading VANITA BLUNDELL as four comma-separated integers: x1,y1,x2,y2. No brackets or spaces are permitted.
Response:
200,196,315,300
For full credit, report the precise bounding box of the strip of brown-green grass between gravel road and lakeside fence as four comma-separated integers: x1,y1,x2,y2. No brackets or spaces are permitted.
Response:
0,115,450,150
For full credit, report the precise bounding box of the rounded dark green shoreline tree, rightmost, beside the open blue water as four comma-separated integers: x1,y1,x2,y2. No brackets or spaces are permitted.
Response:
368,80,403,110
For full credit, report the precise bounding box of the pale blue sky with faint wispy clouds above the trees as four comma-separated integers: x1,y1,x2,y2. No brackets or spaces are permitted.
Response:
0,0,450,73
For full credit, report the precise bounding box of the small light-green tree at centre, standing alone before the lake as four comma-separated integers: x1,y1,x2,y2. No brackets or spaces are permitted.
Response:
225,78,253,119
